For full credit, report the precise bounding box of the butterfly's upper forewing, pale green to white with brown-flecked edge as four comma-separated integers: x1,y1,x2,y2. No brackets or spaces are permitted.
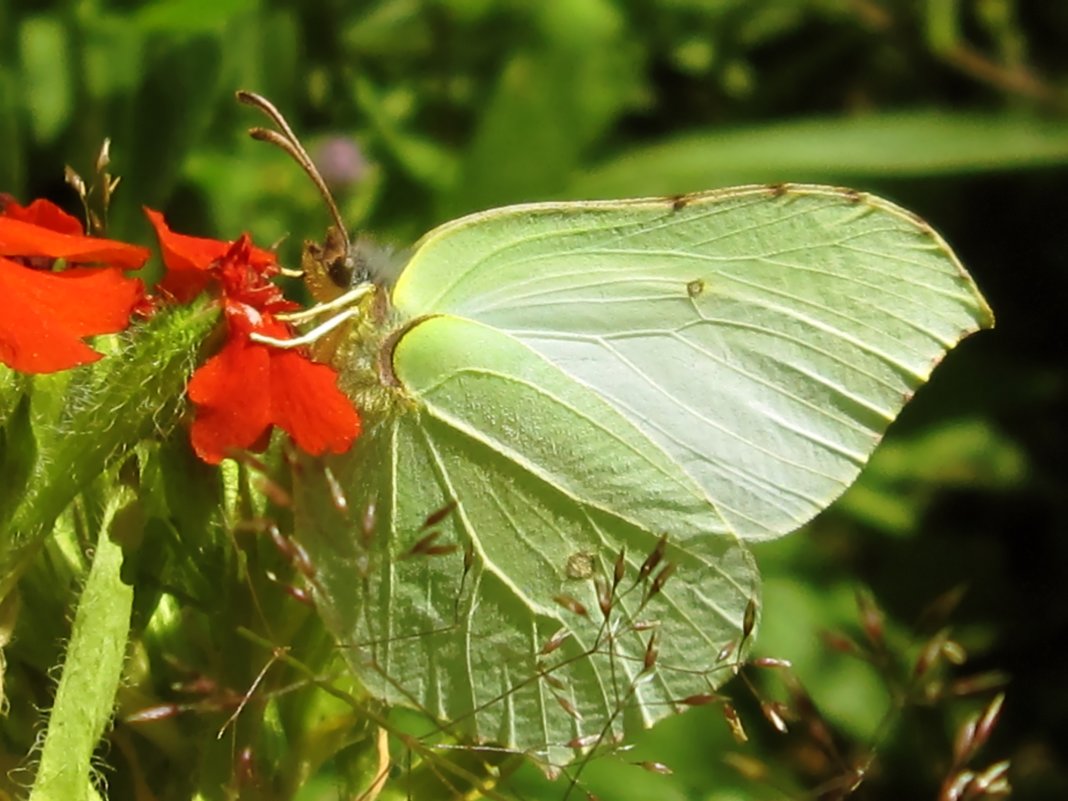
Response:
393,186,992,539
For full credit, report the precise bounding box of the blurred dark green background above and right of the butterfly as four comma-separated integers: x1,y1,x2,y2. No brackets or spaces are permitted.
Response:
0,0,1068,801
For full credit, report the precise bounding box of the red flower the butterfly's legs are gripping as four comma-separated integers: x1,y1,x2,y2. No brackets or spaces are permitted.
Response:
145,209,360,464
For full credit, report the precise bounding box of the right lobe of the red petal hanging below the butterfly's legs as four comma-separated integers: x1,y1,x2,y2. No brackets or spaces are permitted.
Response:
270,348,361,456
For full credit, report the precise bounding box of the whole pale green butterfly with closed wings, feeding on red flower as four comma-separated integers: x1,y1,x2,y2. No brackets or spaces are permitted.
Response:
246,93,993,770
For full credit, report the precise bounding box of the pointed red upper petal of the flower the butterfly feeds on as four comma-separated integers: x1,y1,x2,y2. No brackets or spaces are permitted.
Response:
144,207,278,302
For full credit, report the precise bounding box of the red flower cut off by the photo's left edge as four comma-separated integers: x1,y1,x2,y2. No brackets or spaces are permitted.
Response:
0,198,148,373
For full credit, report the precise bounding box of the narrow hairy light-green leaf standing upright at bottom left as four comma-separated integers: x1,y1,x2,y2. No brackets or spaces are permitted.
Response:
30,491,134,801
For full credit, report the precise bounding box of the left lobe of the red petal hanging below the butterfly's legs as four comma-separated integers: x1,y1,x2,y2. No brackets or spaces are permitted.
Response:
188,336,270,465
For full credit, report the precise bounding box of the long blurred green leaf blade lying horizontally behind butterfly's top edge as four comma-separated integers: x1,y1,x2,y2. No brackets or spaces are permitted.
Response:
568,110,1068,198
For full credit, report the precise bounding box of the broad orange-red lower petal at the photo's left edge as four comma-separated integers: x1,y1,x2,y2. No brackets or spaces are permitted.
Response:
0,258,143,373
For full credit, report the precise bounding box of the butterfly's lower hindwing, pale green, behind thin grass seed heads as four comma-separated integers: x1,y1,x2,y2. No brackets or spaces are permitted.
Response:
297,315,759,772
